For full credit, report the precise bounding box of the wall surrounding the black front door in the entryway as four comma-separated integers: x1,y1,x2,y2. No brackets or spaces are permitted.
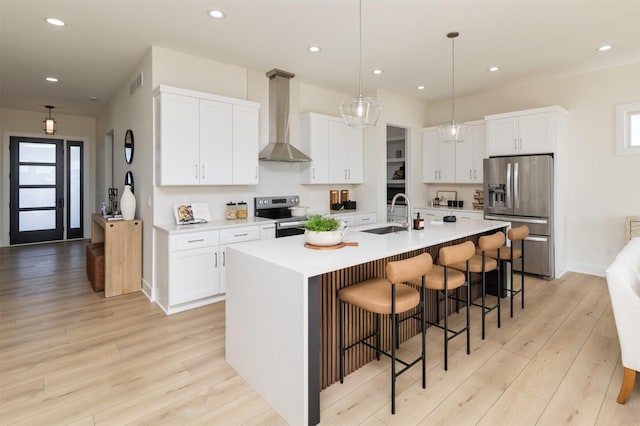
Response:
0,108,96,247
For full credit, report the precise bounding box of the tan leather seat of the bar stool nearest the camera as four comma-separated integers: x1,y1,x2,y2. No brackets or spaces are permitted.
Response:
338,277,422,315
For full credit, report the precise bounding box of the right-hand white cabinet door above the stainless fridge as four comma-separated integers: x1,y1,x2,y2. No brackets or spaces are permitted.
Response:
518,113,555,154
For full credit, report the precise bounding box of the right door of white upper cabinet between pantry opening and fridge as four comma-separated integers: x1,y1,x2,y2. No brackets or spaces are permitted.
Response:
455,121,487,183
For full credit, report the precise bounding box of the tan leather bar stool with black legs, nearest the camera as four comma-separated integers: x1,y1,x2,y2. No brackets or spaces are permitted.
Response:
338,253,433,414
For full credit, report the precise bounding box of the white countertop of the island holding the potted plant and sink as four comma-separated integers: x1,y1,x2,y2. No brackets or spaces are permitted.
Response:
232,219,509,277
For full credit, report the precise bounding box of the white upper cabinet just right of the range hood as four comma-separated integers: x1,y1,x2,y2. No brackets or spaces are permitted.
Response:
300,112,363,184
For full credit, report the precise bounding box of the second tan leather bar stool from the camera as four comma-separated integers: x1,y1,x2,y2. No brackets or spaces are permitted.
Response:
414,241,476,371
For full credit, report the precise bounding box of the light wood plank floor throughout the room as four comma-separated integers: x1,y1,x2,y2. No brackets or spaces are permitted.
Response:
0,241,640,425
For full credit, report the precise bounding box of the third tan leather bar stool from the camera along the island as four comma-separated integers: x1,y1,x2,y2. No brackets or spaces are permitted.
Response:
450,232,504,340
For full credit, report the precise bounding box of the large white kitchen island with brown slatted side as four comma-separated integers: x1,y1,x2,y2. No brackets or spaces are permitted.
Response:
225,220,509,425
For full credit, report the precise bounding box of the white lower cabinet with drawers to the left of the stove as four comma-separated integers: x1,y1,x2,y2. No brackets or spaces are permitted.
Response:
155,223,264,314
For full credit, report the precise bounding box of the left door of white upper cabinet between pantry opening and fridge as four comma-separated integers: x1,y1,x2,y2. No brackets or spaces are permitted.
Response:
422,127,456,183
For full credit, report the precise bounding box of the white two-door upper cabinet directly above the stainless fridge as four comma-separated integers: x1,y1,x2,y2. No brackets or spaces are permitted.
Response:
485,106,568,156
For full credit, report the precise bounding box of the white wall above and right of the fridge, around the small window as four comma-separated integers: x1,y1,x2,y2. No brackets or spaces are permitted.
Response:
427,63,640,275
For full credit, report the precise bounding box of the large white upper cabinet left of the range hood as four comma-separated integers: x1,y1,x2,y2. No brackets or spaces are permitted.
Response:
154,86,259,185
